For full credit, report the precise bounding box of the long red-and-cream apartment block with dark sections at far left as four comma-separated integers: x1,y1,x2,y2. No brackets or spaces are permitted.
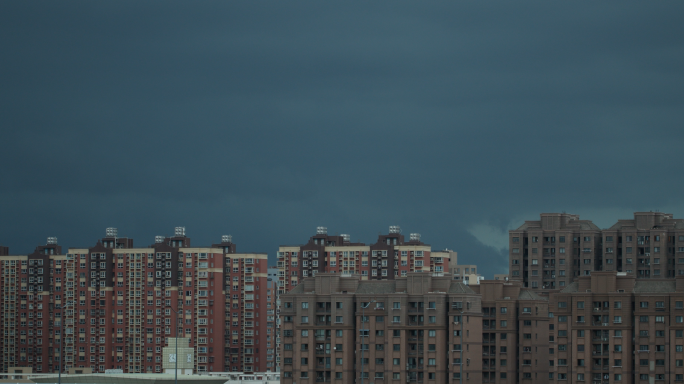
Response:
0,227,275,372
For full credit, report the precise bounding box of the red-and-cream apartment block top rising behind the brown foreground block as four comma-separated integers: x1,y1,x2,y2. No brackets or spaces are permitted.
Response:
278,226,457,293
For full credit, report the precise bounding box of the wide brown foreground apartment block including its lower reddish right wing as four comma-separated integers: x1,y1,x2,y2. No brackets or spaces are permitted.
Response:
280,273,549,384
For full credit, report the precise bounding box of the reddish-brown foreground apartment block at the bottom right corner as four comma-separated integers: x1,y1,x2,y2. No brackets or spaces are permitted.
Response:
549,271,684,383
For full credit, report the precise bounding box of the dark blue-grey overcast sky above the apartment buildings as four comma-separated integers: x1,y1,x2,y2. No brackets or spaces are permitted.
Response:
0,1,684,277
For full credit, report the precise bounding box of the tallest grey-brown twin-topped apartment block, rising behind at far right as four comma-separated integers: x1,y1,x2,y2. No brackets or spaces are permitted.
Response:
509,212,684,292
